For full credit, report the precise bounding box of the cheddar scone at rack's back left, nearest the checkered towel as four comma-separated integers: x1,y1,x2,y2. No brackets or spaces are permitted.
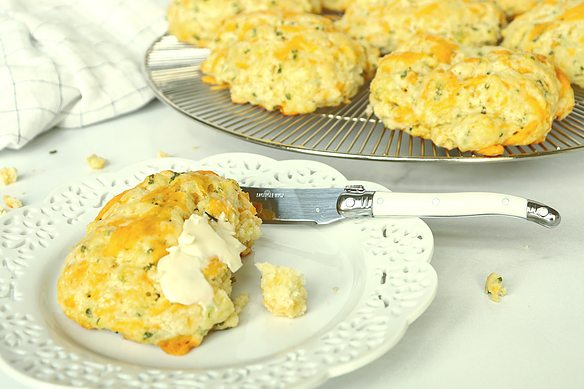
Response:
166,0,322,47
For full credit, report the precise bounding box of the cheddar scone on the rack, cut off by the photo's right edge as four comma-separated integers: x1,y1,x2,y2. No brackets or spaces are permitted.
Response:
501,0,584,88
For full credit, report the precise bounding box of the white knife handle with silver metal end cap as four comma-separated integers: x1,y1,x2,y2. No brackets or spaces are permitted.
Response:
372,191,560,227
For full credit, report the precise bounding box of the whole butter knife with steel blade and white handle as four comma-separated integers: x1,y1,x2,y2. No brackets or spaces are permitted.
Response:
242,185,561,228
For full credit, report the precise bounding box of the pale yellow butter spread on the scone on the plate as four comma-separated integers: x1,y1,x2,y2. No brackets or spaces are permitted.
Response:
157,214,245,307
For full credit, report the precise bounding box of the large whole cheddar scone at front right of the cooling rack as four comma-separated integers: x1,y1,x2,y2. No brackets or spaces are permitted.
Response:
370,35,574,156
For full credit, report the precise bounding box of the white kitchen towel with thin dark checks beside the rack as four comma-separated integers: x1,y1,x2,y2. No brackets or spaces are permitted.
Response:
0,0,166,149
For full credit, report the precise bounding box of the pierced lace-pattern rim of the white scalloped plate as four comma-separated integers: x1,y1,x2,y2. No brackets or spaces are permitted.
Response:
0,153,437,389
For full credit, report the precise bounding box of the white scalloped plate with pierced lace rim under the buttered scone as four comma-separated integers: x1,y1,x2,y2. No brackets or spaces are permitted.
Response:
0,154,437,389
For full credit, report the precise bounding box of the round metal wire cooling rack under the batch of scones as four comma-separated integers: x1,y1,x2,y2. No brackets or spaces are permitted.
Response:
144,35,584,162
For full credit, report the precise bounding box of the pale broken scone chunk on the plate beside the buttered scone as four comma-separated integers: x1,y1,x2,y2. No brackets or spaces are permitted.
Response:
256,262,308,319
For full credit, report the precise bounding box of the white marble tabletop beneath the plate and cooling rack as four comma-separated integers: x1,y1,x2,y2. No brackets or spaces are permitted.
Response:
0,98,584,389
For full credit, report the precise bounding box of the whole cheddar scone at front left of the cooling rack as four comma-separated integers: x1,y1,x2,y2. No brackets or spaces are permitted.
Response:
201,11,379,115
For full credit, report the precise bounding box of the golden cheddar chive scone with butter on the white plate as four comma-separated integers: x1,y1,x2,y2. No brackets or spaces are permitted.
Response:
57,171,261,355
